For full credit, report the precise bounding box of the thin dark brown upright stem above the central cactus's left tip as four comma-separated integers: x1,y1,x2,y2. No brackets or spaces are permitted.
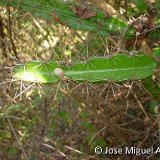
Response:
7,7,19,59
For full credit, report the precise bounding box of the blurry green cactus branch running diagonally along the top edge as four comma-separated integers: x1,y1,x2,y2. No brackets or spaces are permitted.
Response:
0,0,135,39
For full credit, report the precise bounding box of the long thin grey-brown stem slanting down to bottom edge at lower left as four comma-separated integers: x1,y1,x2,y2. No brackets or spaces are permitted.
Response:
0,98,29,160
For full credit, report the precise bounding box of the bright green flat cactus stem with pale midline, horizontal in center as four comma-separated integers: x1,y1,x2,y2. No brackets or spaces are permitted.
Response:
13,54,157,83
